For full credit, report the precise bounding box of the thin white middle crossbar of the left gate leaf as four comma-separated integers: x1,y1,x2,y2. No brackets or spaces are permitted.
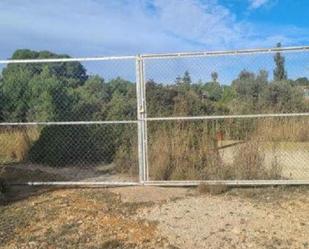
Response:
0,120,138,126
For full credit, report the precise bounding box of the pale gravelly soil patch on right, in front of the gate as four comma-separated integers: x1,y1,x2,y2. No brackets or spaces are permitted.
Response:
138,189,309,249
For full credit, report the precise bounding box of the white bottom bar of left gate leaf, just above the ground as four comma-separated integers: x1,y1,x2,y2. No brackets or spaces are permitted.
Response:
21,181,141,186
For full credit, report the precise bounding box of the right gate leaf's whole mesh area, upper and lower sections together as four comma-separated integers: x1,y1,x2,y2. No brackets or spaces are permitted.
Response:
144,47,309,185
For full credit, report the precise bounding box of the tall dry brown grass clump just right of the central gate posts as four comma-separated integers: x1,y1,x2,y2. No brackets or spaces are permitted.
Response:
149,122,226,180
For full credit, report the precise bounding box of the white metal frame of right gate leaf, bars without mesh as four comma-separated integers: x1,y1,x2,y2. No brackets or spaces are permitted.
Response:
138,46,309,187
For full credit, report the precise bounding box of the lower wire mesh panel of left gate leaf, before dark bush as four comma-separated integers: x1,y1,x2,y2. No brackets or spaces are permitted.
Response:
0,123,138,183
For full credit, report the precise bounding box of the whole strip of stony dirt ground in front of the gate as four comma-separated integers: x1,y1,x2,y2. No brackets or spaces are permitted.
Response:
0,187,309,249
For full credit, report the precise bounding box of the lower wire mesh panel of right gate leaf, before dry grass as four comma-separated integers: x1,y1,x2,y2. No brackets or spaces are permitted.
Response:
148,117,309,181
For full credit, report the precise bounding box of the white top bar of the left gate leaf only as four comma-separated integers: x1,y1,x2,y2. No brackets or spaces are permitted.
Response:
0,56,136,64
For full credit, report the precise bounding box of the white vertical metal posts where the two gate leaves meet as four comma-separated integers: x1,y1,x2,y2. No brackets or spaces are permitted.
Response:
136,55,148,184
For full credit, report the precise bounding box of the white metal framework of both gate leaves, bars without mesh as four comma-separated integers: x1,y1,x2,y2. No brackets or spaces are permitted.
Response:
0,46,309,187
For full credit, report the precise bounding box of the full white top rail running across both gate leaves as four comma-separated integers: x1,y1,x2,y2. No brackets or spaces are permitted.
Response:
0,46,309,64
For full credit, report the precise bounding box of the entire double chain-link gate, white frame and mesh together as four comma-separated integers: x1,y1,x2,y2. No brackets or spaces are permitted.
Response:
0,47,309,185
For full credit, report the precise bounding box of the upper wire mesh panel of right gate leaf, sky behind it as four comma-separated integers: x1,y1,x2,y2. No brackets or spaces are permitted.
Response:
145,51,309,117
